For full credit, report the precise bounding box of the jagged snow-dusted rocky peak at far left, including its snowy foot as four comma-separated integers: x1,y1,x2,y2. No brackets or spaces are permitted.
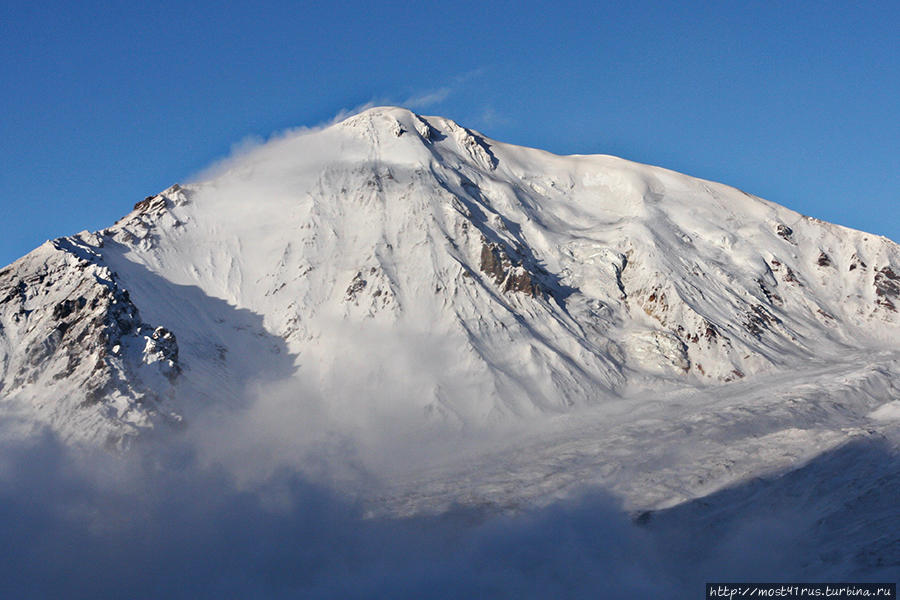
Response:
0,236,180,443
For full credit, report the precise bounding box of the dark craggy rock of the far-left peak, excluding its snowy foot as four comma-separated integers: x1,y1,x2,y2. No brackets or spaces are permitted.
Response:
0,239,180,422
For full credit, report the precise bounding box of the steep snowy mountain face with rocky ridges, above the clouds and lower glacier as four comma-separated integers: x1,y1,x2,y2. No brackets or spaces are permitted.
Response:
0,109,900,437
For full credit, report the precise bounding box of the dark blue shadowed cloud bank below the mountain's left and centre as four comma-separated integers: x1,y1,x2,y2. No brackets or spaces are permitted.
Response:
0,428,676,598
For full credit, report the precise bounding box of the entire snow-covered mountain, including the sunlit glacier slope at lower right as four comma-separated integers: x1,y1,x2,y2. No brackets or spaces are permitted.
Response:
0,108,900,552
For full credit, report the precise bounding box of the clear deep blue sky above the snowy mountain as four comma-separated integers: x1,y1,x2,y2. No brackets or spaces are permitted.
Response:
0,0,900,264
